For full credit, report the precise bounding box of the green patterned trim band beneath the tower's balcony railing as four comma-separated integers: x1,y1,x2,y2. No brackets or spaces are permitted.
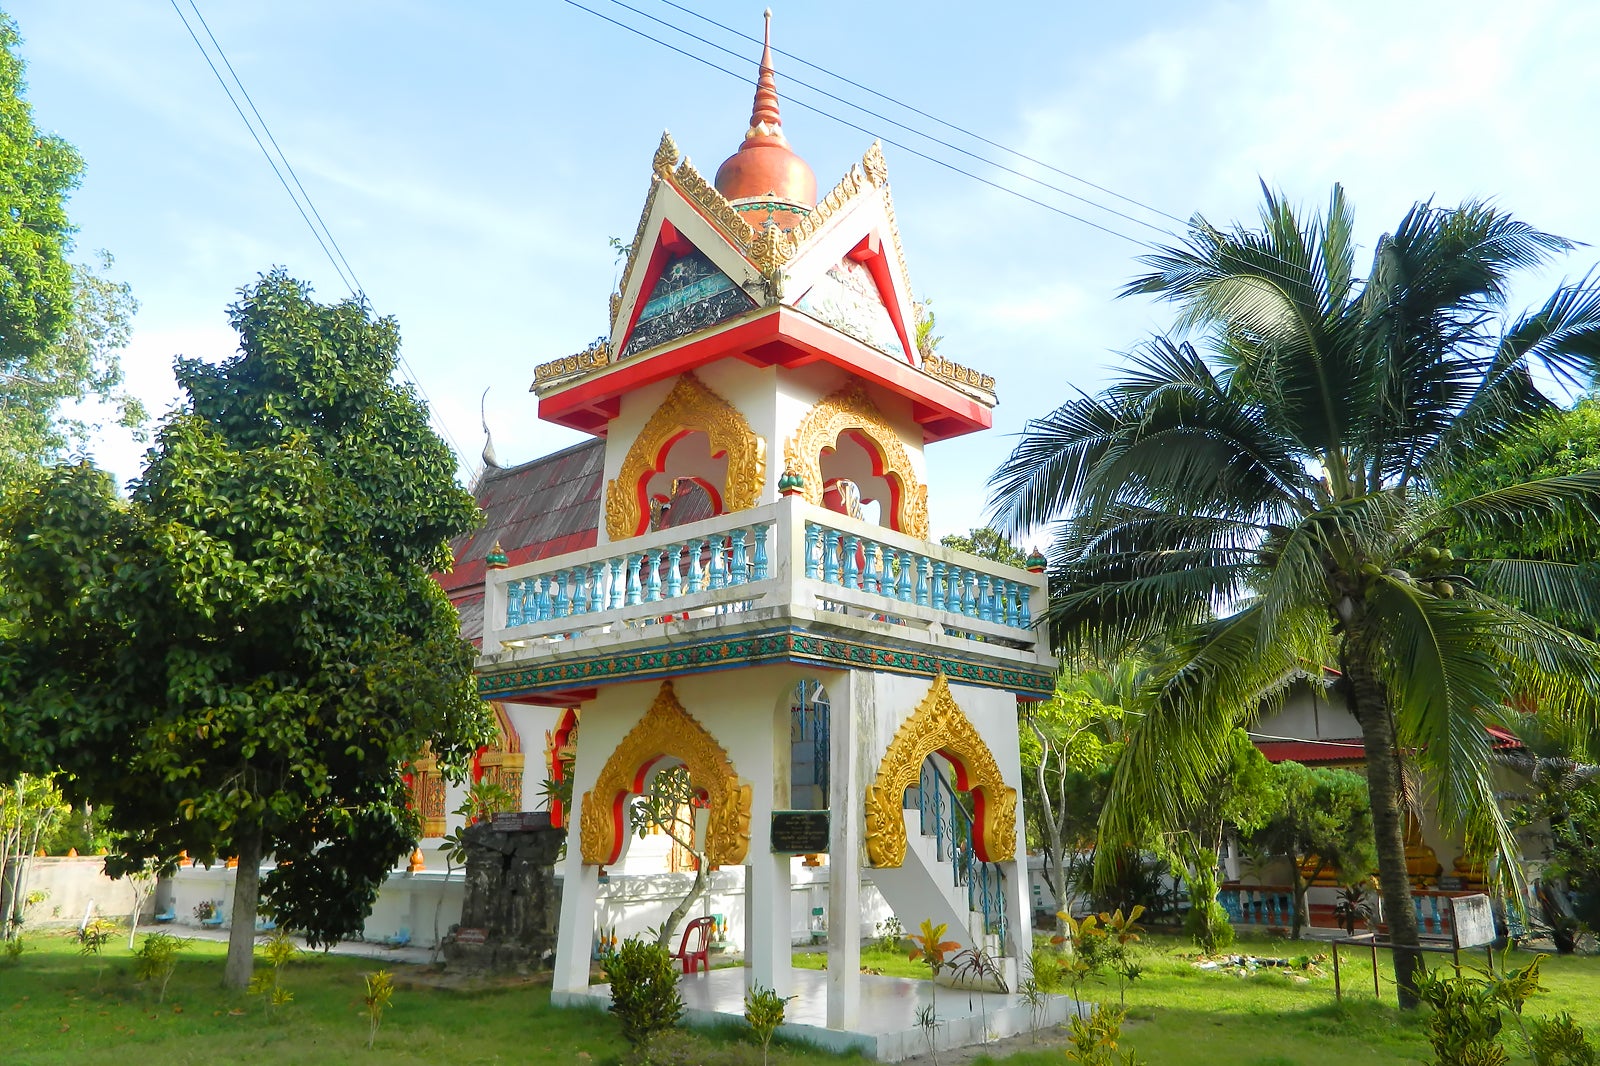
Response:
478,629,1056,699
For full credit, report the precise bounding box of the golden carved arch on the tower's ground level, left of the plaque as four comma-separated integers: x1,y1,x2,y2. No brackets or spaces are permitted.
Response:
578,680,750,866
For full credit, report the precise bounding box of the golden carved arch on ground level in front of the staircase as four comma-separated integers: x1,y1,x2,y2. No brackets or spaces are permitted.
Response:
867,674,1016,866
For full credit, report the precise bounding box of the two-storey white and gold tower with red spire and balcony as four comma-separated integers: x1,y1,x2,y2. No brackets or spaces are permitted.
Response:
474,14,1056,1060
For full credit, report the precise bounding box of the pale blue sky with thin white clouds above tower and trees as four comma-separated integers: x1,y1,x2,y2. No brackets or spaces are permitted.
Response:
12,0,1600,535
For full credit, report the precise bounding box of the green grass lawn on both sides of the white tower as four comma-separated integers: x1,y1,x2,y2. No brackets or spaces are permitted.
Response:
0,933,1600,1066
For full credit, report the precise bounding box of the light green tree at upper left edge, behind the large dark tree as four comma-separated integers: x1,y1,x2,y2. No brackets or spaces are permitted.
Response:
0,14,144,482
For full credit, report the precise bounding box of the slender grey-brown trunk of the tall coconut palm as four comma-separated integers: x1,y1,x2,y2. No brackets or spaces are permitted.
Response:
1344,655,1422,1010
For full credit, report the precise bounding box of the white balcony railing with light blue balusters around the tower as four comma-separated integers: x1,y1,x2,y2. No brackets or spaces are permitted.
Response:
483,498,1050,663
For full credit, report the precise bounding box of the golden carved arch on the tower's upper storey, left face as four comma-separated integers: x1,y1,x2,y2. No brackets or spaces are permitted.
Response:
605,371,766,541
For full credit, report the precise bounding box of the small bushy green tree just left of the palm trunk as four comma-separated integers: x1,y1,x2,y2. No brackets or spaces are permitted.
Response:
1245,762,1378,940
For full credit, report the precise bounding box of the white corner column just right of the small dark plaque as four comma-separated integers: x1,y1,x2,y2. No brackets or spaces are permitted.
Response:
827,671,872,1029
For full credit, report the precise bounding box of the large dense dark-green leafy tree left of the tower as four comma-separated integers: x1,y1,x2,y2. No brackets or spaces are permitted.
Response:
0,271,490,988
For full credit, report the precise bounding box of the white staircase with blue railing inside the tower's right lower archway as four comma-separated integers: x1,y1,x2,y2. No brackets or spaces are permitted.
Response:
870,757,1018,989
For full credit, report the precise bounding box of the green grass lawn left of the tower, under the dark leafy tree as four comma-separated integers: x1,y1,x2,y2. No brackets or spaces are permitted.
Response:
0,930,846,1066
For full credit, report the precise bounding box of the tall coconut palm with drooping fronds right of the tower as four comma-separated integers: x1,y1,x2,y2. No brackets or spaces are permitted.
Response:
990,186,1600,1005
